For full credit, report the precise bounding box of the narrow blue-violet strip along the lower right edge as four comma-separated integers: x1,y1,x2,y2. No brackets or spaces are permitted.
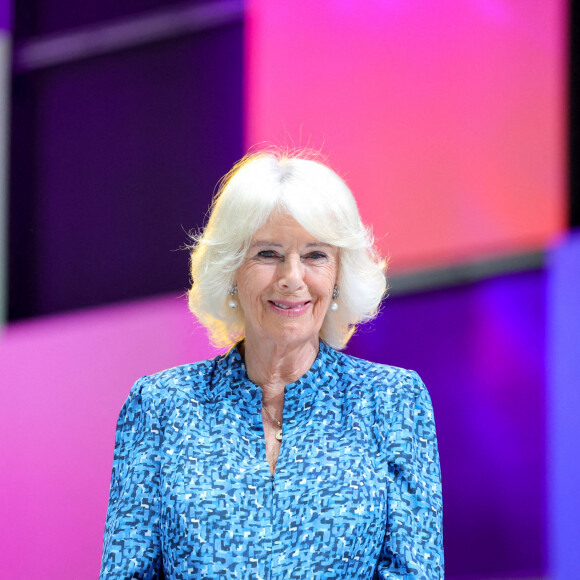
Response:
548,230,580,580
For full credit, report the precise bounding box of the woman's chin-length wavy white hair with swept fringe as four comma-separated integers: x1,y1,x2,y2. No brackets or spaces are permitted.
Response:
189,152,387,349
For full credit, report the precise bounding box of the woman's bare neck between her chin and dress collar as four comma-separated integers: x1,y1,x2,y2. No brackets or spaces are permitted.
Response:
240,337,319,398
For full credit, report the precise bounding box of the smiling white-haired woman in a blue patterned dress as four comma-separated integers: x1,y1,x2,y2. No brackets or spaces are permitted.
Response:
101,153,443,580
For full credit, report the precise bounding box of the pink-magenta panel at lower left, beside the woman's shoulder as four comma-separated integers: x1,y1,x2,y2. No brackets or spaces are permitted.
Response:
0,297,216,580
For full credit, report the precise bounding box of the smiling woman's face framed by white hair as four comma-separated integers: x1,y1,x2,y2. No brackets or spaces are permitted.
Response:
236,214,338,345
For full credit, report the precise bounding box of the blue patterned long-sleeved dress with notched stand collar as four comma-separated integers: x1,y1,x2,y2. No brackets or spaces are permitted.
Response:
100,343,443,580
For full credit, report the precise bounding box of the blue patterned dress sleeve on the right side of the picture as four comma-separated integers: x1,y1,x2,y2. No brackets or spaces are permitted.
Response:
374,372,444,580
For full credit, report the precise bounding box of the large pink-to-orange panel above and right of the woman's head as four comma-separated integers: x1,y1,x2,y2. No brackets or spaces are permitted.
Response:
246,0,567,270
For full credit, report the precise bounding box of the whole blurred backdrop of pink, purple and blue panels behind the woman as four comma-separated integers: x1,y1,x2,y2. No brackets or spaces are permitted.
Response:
0,0,580,580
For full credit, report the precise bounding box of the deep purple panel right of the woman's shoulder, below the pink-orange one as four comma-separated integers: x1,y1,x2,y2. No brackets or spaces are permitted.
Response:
349,271,546,578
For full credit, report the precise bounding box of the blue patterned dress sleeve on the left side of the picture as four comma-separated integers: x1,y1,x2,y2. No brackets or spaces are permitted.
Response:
99,377,163,580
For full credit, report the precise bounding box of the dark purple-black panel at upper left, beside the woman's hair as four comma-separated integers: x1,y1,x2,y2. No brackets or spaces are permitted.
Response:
9,23,243,320
